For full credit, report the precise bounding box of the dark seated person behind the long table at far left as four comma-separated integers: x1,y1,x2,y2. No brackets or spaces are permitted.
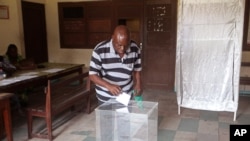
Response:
4,44,37,70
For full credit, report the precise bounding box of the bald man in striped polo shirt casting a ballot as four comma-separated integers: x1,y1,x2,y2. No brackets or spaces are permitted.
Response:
89,25,142,104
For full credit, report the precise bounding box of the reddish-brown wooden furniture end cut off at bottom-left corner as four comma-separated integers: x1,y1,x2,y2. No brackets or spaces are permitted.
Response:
0,93,13,141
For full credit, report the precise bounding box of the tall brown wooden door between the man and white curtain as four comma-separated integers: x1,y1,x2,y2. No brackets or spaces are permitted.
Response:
143,0,177,91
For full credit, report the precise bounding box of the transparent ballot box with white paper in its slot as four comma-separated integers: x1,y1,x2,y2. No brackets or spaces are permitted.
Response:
95,100,158,141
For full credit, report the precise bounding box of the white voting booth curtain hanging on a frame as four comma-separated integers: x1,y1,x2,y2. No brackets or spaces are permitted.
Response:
176,0,245,112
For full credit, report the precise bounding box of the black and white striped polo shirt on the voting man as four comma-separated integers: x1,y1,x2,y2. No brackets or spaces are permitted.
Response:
89,40,142,102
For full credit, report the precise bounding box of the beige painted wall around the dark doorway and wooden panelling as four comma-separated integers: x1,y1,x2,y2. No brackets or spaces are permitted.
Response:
0,0,250,66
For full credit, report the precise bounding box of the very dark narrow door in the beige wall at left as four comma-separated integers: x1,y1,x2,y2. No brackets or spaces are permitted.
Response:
22,1,48,63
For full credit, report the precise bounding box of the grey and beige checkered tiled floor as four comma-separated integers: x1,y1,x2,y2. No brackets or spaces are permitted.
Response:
1,90,250,141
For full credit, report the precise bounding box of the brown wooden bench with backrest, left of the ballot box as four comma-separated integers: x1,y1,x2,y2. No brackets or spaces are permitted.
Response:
27,72,94,141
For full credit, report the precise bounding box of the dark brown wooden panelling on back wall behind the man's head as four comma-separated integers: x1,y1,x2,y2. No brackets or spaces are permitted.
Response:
58,0,143,48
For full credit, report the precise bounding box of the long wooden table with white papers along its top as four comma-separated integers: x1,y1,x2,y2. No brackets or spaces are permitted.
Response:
0,63,84,93
